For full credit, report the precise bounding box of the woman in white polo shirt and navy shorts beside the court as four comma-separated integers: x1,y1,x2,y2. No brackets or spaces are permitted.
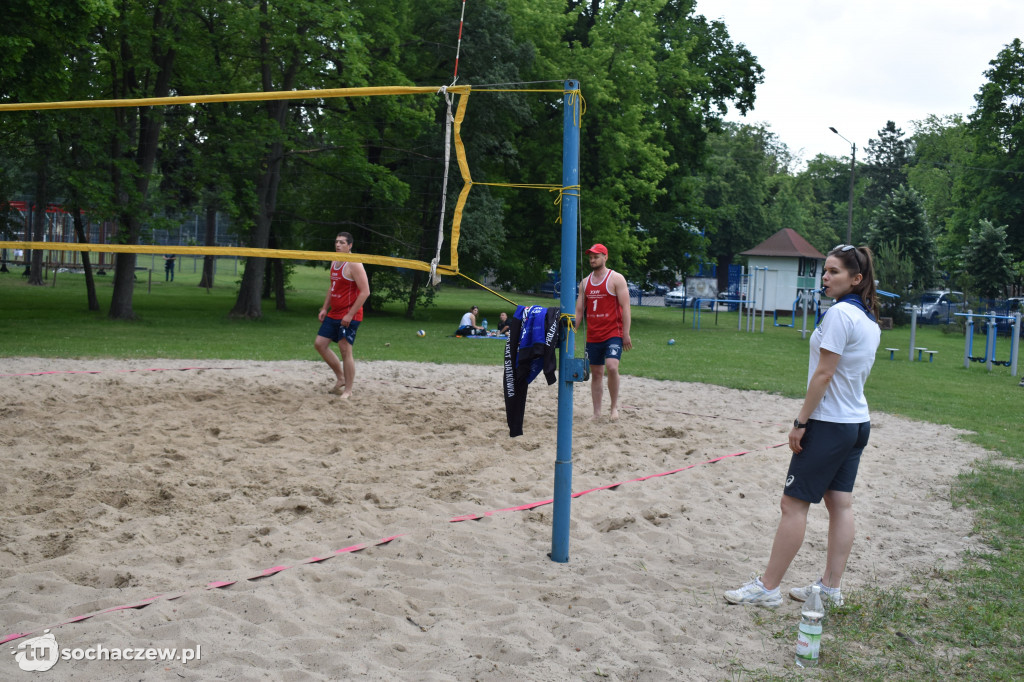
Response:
725,244,882,606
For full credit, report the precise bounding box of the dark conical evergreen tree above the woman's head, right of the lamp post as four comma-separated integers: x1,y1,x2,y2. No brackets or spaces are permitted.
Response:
867,185,935,288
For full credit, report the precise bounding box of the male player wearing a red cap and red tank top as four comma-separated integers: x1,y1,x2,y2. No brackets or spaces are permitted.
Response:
575,244,633,419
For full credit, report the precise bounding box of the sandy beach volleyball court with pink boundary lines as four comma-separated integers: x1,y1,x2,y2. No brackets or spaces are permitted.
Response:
0,358,983,681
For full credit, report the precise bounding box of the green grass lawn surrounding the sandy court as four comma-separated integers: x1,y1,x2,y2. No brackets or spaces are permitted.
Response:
0,258,1024,680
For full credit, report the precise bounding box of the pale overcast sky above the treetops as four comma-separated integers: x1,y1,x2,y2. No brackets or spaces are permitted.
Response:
696,0,1024,162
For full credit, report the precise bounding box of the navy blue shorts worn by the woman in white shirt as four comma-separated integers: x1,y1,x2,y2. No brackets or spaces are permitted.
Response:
782,419,871,504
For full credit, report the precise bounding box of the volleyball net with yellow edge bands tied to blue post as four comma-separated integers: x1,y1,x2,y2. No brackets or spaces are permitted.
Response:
0,85,584,284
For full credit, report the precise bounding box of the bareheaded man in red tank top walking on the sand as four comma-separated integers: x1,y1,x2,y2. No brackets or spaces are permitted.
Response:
313,232,370,399
